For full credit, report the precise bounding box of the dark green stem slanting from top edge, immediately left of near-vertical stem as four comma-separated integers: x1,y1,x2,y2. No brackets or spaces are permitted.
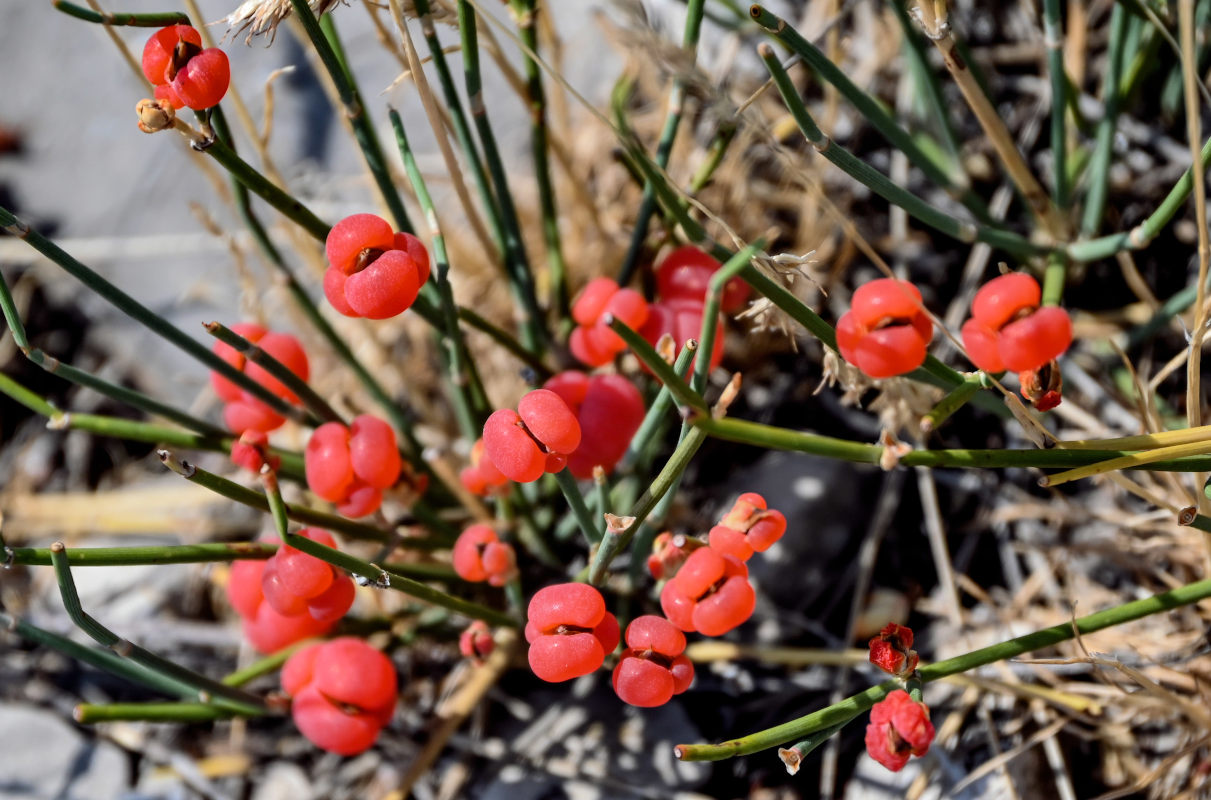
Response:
458,0,547,350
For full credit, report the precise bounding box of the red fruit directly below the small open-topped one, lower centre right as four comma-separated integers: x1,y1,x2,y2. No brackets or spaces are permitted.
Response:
660,547,757,637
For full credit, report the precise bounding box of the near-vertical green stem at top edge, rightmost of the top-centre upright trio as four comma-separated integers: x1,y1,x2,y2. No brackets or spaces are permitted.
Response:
509,0,570,320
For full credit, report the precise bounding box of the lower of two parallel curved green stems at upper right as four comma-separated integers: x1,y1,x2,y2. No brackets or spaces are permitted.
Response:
754,47,1046,258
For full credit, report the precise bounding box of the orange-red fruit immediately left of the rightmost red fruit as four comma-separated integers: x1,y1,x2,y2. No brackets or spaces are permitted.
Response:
837,278,934,378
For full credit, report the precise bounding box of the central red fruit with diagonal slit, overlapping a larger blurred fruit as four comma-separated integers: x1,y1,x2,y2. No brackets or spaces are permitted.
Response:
483,389,580,483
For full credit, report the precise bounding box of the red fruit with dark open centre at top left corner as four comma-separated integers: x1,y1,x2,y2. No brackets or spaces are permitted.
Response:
143,25,231,110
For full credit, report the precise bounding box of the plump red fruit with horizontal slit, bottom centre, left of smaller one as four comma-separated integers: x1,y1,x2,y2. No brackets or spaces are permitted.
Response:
526,583,619,683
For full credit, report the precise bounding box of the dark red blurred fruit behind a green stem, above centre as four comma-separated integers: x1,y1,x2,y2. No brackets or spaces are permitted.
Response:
639,244,748,369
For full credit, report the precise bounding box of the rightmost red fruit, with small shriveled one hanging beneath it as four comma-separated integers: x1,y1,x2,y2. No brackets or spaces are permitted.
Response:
960,272,1072,373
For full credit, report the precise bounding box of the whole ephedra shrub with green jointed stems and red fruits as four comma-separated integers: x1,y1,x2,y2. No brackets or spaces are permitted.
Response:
7,0,1211,792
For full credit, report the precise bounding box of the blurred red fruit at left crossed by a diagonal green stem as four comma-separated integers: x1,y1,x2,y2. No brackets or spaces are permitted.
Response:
211,322,311,433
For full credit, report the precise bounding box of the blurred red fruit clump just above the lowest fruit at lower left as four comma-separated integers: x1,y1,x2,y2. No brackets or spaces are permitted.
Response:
226,528,354,652
